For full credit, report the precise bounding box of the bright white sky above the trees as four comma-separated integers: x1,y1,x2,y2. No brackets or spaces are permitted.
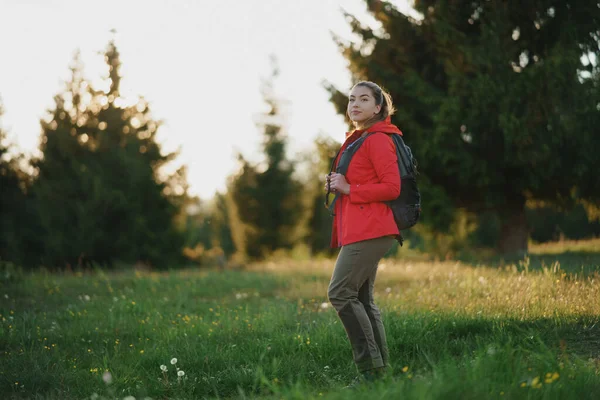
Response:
0,0,408,199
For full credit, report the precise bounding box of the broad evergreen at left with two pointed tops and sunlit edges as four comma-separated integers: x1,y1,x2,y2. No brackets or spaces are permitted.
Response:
34,42,187,266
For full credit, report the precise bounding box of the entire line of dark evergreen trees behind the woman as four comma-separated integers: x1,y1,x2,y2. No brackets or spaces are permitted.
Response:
0,1,600,268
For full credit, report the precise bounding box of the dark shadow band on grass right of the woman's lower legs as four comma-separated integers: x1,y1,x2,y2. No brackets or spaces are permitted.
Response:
386,313,600,362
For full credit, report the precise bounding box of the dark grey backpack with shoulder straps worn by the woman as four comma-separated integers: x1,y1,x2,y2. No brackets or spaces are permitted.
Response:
325,132,421,245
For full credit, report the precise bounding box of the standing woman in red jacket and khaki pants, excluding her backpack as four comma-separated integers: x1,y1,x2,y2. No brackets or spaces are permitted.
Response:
325,81,402,387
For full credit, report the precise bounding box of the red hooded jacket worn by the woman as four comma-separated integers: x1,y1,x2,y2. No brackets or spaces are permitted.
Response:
331,117,402,247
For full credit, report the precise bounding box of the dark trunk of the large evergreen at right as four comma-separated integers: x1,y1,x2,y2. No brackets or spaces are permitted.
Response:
498,198,529,257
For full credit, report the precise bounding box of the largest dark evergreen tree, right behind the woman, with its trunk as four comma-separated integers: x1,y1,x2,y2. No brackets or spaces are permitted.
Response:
330,0,600,253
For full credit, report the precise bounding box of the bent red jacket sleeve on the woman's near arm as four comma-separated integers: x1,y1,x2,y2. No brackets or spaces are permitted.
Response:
350,133,400,203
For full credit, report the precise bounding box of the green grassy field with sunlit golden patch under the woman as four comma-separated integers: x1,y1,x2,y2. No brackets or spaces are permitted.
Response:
0,240,600,400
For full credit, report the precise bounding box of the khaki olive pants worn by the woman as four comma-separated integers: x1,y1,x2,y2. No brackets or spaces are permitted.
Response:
327,236,395,372
